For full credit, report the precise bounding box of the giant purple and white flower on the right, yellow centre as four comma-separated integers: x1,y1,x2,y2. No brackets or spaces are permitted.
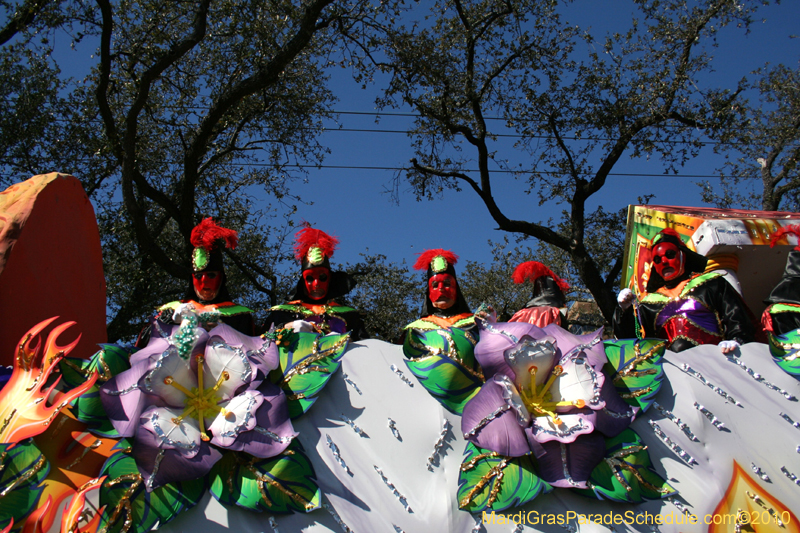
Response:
461,322,635,488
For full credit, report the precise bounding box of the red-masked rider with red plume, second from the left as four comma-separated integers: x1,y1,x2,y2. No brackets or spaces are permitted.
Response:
264,227,369,341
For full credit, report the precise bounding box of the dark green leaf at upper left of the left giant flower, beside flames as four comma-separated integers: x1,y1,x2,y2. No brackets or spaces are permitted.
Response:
59,344,131,438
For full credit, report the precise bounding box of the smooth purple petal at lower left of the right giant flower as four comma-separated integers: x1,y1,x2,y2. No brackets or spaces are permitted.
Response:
461,380,531,457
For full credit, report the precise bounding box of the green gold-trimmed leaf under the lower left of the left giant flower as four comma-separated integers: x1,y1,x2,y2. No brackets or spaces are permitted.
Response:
97,440,205,533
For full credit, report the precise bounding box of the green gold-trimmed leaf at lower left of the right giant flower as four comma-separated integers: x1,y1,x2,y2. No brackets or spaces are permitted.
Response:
458,442,553,513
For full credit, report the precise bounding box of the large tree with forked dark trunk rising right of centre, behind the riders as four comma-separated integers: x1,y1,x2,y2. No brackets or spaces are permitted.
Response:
362,0,754,319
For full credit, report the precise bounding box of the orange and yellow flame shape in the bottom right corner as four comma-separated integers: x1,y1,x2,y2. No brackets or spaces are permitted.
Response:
708,461,800,533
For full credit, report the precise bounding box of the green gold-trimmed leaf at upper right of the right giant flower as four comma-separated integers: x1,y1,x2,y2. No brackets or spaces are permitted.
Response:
604,339,667,412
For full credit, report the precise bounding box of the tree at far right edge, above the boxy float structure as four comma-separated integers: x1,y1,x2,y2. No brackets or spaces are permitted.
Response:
703,65,800,211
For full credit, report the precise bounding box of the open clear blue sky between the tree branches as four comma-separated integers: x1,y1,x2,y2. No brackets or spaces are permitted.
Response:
290,0,800,274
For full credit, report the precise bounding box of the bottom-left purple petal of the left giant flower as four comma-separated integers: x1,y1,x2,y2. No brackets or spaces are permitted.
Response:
131,420,222,492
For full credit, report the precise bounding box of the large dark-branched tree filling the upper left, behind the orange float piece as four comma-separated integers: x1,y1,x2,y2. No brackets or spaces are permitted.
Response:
0,0,380,340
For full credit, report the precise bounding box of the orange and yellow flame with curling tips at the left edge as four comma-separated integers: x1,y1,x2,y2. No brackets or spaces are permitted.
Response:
0,316,97,444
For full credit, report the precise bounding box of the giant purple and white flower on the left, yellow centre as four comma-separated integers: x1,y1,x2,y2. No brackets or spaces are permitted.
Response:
100,320,296,490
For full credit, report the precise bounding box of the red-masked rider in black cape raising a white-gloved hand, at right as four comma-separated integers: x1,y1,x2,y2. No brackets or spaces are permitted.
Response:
615,228,755,353
